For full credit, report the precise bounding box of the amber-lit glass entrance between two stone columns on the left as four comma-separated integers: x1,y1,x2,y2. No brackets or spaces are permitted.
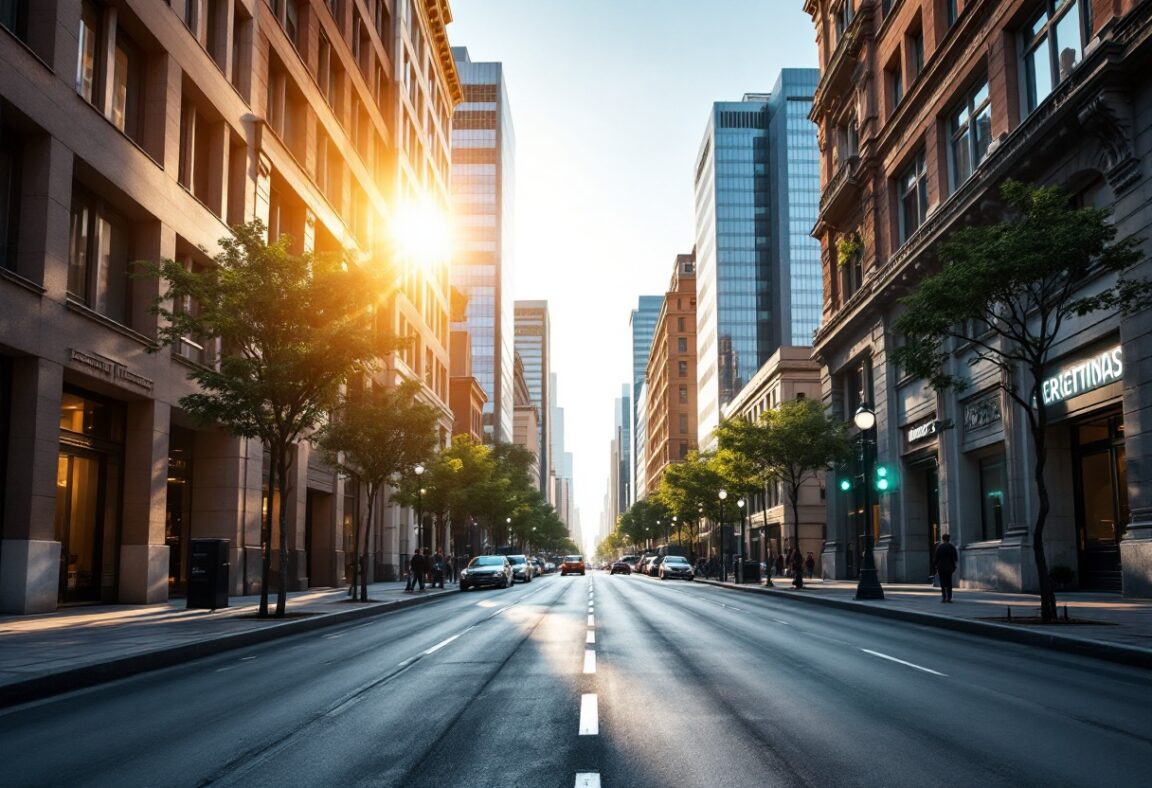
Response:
55,387,124,604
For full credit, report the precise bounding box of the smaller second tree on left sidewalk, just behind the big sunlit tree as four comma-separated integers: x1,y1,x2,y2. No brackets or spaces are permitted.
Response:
313,380,439,601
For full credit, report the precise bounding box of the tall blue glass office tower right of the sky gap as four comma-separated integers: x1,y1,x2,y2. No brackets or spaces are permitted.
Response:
695,69,823,448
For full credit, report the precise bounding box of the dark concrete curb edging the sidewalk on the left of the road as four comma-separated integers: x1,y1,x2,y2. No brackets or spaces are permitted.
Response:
0,590,448,709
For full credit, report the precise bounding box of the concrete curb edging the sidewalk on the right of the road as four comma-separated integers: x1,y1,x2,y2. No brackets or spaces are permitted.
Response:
696,577,1152,669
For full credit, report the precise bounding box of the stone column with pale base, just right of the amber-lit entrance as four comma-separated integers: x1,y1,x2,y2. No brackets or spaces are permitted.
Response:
120,400,172,605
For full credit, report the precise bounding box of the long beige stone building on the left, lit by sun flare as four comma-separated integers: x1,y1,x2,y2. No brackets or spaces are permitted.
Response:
0,0,460,613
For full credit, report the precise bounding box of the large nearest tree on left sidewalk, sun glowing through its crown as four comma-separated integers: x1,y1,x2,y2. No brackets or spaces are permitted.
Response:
147,220,395,617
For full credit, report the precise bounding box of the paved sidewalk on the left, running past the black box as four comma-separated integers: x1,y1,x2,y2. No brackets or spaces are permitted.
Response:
0,581,456,709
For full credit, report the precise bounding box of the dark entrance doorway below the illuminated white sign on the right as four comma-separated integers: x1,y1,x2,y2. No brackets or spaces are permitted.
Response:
1073,414,1129,591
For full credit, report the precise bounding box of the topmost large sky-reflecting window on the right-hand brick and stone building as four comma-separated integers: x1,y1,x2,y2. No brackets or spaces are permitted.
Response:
1023,0,1091,112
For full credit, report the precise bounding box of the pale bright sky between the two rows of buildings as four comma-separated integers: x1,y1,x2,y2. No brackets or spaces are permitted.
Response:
448,0,817,550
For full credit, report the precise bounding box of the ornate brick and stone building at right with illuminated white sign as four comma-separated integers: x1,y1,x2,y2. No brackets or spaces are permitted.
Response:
804,0,1152,597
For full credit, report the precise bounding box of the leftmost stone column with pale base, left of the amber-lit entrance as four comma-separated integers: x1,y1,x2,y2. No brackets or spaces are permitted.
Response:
0,357,63,613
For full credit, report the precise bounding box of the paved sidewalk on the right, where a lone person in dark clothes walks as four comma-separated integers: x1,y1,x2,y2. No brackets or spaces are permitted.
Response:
696,577,1152,668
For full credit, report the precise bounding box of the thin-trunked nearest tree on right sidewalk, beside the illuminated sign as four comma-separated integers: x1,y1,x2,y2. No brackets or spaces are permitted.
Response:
894,182,1152,622
